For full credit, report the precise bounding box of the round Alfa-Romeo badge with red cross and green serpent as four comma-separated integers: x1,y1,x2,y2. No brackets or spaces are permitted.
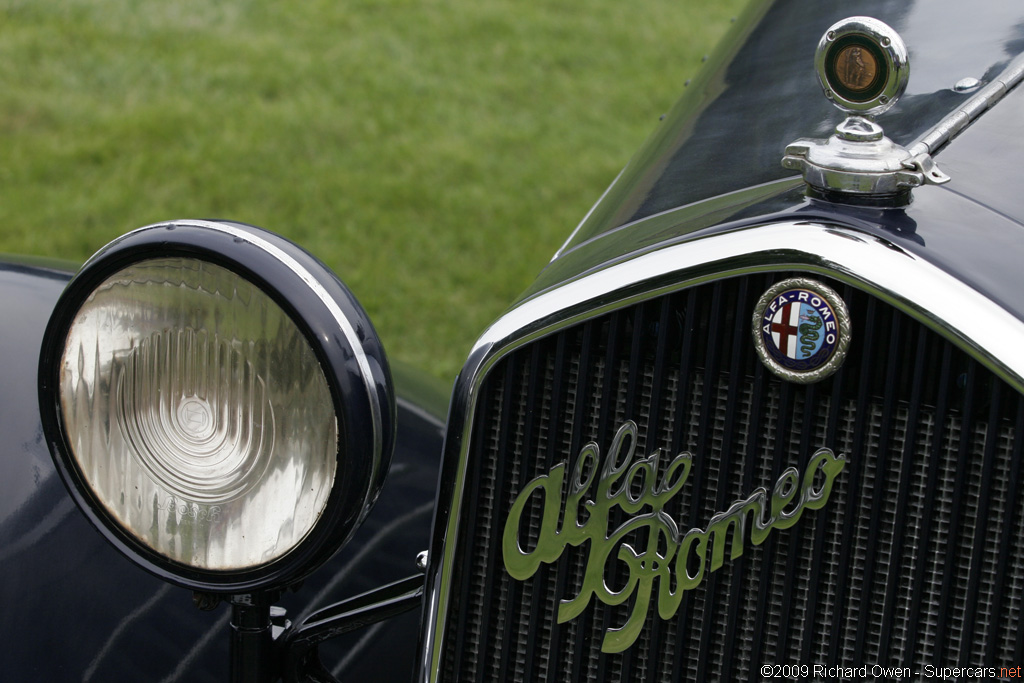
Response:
754,278,850,384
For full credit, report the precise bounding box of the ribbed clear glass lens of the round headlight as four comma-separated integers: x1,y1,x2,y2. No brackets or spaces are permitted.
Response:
60,258,338,569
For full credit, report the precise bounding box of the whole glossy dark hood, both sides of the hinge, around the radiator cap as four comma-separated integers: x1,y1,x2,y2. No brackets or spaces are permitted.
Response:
520,0,1024,318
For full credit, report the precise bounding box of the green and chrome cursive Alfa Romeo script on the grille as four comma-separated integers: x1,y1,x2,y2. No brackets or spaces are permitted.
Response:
502,420,846,653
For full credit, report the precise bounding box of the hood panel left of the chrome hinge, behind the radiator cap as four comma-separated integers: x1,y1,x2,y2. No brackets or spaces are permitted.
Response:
563,0,1024,246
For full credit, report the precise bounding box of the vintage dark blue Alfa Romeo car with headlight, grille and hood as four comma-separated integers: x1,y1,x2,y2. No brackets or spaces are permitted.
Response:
0,0,1024,683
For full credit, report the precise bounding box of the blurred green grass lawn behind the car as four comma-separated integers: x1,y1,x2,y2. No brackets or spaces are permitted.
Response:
6,0,740,380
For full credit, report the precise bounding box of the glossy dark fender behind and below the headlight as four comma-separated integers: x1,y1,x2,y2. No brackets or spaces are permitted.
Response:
0,259,447,682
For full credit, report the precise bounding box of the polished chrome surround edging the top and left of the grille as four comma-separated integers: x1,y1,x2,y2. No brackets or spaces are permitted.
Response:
420,221,1024,683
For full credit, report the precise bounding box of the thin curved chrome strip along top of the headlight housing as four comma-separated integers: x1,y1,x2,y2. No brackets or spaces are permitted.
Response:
119,219,384,506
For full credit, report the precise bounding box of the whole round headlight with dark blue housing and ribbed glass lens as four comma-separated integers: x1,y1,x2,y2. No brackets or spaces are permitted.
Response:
40,221,394,592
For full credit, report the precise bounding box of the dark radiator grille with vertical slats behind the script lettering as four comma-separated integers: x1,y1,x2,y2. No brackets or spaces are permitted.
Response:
442,274,1024,681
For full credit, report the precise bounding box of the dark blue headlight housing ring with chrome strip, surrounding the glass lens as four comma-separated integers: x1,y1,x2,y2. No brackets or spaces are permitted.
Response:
39,220,396,593
